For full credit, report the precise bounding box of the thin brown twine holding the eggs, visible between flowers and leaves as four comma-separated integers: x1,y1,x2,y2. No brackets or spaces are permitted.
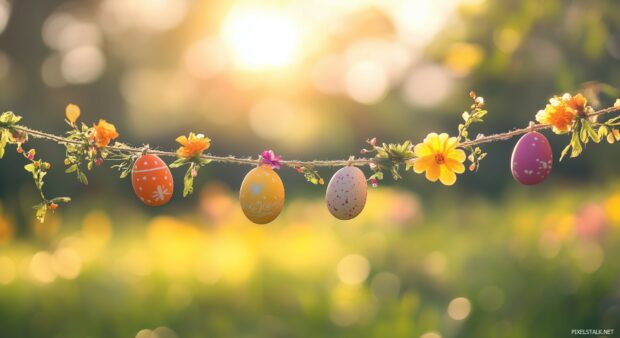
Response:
13,106,620,167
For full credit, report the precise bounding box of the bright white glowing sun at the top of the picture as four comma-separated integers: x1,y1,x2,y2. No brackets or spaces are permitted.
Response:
221,7,300,70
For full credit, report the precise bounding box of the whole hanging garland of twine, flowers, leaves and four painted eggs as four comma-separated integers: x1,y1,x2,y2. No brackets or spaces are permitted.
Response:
0,92,620,224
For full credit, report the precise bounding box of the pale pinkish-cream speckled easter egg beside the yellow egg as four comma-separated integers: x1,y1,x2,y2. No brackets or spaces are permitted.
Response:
325,166,368,220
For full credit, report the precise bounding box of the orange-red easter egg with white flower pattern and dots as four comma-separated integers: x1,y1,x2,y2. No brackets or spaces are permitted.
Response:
131,154,174,207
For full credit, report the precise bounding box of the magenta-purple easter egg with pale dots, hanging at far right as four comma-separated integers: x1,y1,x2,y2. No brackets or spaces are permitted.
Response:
510,131,553,185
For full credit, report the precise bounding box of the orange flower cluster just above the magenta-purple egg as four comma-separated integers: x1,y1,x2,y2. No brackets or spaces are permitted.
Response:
536,94,588,134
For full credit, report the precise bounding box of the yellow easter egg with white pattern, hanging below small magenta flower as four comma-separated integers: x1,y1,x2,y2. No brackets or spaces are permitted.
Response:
239,165,284,224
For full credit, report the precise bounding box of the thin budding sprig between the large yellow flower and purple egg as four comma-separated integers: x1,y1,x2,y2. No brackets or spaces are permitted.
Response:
457,91,488,171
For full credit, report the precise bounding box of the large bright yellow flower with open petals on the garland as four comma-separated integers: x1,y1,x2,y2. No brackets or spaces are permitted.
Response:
413,133,465,185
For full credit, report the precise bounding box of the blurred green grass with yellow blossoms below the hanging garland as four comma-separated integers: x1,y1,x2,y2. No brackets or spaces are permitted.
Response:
0,182,620,338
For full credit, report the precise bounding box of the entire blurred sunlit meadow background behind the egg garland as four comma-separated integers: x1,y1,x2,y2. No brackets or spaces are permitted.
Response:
0,0,620,338
